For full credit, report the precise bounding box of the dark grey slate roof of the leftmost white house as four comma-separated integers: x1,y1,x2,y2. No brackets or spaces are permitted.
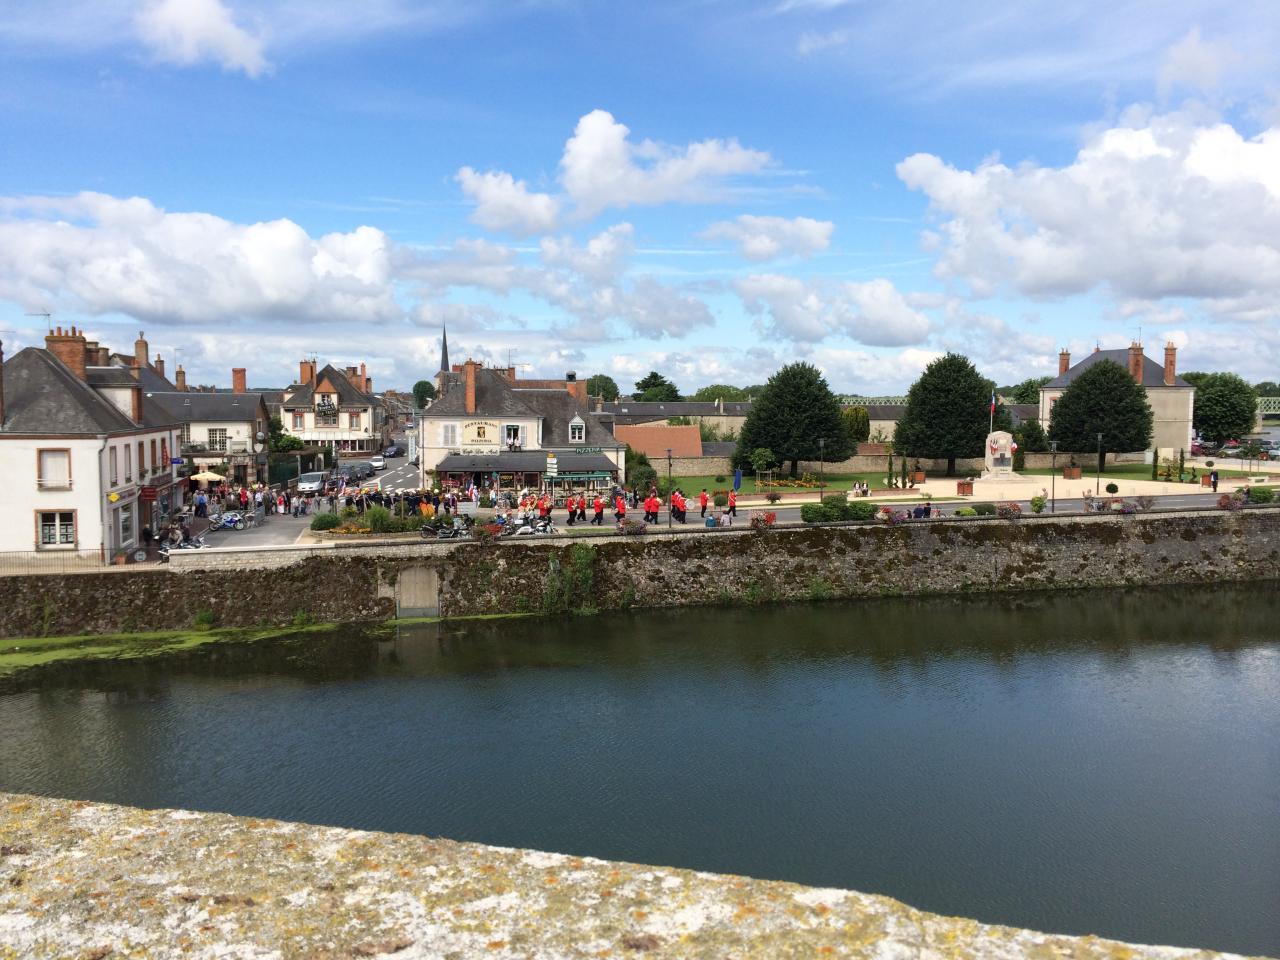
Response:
0,347,138,436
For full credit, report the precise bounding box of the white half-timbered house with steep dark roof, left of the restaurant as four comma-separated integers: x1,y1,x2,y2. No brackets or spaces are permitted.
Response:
280,360,390,457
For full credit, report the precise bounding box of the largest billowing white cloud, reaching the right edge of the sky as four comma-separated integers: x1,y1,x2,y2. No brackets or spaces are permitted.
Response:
897,113,1280,315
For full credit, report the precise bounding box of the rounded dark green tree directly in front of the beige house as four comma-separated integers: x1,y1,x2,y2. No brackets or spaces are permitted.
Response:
1048,360,1153,472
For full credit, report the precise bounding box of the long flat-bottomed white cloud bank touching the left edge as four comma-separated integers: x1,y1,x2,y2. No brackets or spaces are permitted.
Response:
0,193,402,324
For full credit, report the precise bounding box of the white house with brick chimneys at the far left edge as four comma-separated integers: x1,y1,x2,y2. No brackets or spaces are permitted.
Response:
0,326,183,562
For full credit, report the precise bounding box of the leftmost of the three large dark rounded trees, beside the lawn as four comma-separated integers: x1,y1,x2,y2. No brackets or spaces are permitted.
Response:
733,362,851,476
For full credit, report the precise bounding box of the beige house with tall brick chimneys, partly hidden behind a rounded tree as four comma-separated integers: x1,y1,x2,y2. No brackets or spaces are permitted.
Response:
1039,343,1196,457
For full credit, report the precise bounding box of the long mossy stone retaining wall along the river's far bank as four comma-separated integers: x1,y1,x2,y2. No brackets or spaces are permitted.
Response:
0,508,1280,636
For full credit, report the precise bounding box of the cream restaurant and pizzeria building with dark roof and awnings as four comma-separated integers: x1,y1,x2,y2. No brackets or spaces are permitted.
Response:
417,356,626,493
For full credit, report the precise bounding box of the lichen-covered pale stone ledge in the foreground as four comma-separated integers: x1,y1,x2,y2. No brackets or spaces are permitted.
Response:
0,794,1249,960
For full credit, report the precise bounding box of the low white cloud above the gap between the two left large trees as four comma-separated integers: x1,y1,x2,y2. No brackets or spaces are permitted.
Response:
735,274,931,347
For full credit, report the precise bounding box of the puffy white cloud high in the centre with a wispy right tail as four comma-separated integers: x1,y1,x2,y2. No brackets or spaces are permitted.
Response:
561,110,772,216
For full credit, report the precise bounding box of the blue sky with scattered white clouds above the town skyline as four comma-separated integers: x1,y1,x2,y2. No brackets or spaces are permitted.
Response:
0,0,1280,396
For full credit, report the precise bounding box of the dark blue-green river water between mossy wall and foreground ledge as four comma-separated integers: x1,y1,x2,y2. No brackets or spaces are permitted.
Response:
0,584,1280,954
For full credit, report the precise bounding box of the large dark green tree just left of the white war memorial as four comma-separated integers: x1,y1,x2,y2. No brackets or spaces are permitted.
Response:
893,353,993,476
